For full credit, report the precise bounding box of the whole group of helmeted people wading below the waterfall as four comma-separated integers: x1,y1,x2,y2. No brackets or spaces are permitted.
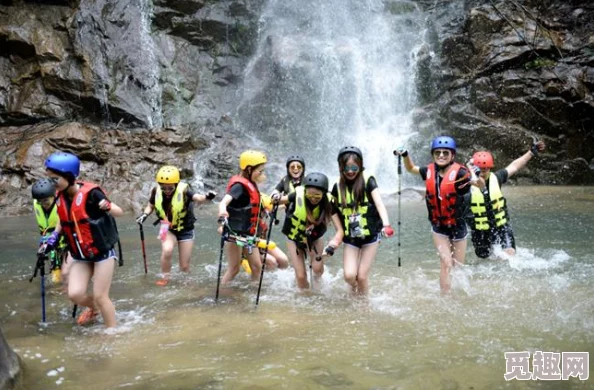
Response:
32,136,544,327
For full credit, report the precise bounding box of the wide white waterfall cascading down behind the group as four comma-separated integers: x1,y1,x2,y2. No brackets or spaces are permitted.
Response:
237,0,424,190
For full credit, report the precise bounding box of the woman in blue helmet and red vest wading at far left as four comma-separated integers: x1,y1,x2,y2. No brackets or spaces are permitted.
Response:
45,152,124,328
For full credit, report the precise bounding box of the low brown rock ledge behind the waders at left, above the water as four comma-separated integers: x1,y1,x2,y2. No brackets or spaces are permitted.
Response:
0,122,234,215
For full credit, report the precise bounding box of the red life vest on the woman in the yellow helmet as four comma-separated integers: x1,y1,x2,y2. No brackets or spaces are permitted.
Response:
226,175,263,235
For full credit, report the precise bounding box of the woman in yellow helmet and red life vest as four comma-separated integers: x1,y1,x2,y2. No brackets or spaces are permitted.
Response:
218,150,267,284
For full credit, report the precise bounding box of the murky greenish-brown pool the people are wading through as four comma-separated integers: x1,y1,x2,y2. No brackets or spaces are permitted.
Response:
0,187,594,390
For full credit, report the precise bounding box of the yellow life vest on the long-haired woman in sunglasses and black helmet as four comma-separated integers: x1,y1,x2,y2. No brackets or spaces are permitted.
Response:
336,172,381,238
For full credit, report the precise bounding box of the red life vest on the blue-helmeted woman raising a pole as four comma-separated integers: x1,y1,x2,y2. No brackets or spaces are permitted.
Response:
425,163,462,226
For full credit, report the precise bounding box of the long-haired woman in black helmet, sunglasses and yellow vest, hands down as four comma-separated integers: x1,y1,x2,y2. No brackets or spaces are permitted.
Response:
332,146,394,296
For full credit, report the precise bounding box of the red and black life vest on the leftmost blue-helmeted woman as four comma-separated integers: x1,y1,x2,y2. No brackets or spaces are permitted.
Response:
56,182,118,259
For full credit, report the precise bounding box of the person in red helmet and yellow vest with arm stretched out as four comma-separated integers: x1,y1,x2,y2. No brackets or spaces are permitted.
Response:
468,141,545,259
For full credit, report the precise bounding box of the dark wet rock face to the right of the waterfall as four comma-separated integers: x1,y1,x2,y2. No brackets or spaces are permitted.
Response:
418,0,594,184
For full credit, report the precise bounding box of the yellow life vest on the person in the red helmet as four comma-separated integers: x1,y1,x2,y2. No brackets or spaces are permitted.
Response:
470,172,508,230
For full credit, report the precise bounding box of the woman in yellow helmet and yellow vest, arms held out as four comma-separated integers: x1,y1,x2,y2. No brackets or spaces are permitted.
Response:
136,165,217,286
